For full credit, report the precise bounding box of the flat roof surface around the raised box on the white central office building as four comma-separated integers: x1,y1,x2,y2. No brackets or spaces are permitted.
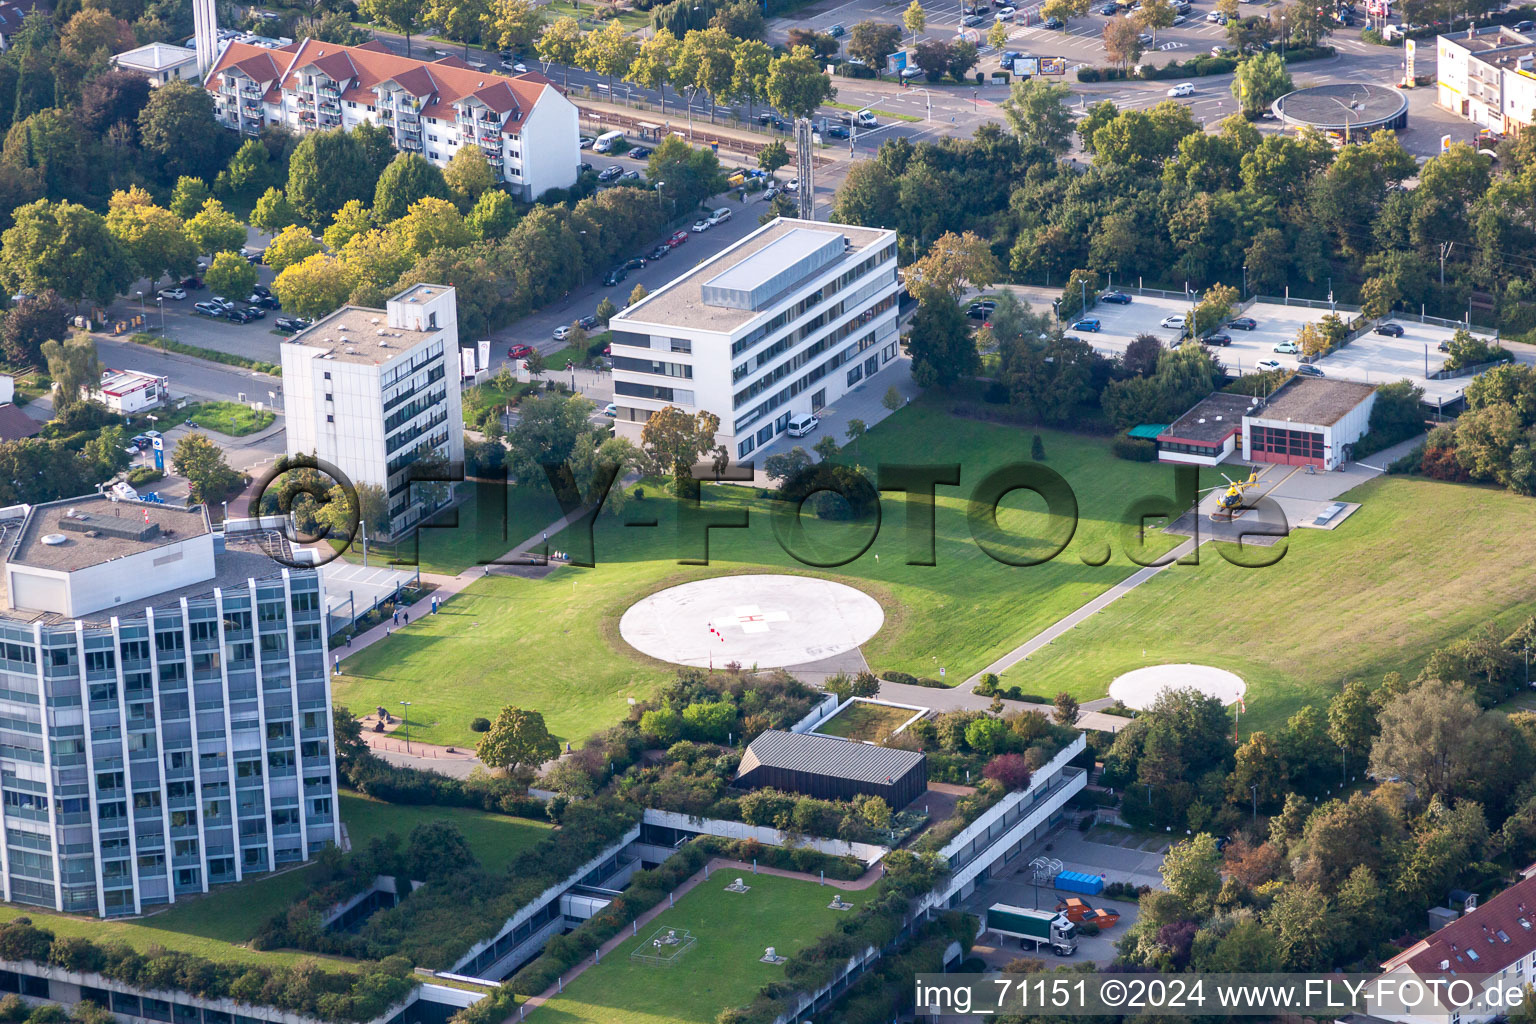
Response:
614,216,895,335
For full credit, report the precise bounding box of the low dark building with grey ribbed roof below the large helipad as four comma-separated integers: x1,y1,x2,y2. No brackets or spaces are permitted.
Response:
736,729,928,811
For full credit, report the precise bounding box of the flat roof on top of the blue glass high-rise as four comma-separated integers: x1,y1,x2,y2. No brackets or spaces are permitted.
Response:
6,494,212,573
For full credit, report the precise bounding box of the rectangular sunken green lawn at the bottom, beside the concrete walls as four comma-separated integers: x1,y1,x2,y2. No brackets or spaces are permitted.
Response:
538,869,868,1024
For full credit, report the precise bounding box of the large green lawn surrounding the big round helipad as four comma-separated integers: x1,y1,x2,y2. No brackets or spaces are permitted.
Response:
335,402,1209,745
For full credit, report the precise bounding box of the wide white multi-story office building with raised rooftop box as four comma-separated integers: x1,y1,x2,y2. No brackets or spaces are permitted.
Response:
610,218,900,459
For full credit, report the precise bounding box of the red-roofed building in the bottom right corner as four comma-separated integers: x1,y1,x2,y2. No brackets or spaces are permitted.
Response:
1376,878,1536,1024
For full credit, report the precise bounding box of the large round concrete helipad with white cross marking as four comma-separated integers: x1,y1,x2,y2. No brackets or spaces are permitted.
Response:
619,576,885,668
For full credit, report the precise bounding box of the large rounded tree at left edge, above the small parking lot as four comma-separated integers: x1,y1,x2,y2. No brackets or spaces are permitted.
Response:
0,200,134,306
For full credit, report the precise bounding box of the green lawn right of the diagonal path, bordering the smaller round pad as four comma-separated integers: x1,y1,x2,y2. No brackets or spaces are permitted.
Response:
1003,476,1536,729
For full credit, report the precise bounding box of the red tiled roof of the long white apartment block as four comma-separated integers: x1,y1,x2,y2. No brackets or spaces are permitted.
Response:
209,38,554,130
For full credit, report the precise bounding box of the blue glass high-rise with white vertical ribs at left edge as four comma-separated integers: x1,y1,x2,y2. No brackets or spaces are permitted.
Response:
0,494,339,917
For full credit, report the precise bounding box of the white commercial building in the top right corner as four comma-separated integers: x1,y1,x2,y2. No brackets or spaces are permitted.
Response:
1435,25,1536,135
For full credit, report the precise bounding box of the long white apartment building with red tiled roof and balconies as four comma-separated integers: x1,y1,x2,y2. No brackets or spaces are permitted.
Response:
204,38,581,200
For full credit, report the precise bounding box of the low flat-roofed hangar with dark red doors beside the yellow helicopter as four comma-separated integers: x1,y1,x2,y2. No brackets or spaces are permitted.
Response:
1243,376,1376,470
